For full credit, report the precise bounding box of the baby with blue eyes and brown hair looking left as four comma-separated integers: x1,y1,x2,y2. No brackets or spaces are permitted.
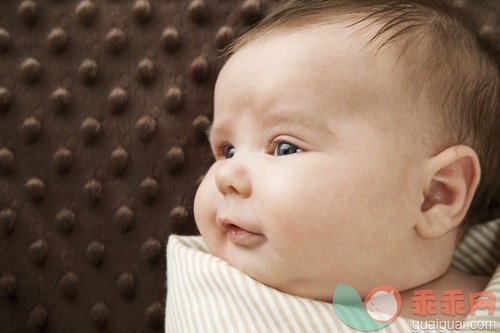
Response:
167,0,500,331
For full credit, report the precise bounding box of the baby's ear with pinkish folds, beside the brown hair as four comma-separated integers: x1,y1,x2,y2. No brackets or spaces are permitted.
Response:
415,145,481,238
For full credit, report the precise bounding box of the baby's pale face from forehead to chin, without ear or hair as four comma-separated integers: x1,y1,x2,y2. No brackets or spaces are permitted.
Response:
194,23,434,301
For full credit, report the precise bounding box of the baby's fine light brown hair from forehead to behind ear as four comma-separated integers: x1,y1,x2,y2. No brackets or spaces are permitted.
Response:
226,0,500,229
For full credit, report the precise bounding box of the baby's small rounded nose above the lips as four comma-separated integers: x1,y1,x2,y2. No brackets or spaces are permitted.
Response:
215,155,252,197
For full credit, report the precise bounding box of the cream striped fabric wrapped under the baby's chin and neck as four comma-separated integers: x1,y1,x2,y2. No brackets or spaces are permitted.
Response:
165,220,500,333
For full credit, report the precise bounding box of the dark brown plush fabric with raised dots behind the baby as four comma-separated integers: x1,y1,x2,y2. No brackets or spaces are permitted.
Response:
0,0,500,333
